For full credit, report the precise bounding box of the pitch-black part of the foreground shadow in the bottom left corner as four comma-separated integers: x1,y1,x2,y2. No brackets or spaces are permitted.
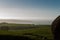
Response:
0,35,34,40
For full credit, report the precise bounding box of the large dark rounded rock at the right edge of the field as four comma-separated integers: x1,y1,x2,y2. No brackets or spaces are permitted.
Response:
51,16,60,40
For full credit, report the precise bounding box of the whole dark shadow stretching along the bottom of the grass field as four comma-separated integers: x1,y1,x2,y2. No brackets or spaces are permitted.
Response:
0,33,52,40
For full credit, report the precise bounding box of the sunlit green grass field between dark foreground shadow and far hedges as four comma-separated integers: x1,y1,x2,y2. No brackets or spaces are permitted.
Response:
0,24,53,39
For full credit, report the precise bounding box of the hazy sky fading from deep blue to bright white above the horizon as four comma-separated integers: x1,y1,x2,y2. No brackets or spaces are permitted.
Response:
0,0,60,20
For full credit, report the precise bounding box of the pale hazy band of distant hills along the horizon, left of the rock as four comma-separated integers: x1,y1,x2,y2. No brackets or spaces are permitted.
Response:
0,19,52,25
